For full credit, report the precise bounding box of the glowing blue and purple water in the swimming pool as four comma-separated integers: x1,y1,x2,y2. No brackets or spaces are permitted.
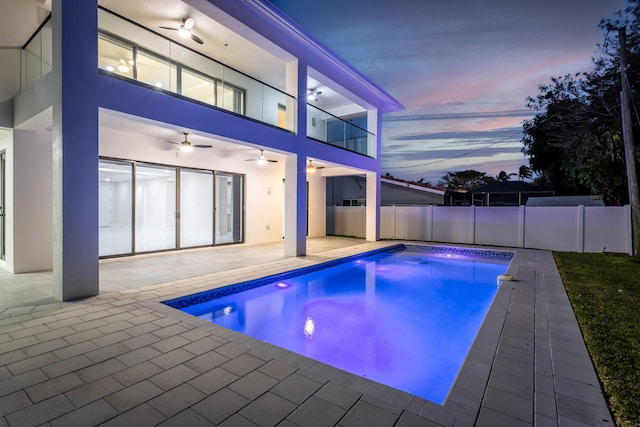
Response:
167,247,510,403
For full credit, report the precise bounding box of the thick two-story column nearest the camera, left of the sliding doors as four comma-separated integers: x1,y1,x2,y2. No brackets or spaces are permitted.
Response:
51,0,99,301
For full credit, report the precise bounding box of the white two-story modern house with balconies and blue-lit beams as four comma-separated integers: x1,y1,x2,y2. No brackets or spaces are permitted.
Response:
0,0,401,300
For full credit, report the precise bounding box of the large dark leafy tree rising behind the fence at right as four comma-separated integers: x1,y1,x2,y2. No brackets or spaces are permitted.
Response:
522,0,640,204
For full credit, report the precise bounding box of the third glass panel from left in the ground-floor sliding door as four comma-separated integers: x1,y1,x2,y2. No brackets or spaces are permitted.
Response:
180,169,213,248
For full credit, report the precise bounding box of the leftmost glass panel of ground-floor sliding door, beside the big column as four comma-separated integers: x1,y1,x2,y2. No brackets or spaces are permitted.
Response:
98,160,133,256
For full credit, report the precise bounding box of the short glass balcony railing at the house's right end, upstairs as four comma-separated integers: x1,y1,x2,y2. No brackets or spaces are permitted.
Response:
307,104,376,158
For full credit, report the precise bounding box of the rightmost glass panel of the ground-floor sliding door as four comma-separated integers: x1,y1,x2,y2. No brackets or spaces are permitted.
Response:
215,172,244,243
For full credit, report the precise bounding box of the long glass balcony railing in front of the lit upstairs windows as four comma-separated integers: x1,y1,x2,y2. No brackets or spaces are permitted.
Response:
98,9,296,132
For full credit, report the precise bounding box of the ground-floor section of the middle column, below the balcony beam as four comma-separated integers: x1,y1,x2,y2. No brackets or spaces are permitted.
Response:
284,154,307,256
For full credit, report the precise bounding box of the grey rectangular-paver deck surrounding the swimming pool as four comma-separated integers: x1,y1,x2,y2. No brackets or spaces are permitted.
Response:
0,238,615,427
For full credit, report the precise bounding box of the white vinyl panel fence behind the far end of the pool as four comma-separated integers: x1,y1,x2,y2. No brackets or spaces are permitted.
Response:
327,206,632,255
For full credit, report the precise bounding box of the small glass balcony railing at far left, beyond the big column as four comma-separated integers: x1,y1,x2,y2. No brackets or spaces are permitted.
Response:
20,15,53,91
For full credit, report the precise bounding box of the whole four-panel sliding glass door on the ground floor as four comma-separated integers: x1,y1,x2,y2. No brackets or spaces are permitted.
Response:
99,159,244,257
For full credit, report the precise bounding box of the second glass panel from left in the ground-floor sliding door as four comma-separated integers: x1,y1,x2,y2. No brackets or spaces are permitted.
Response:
135,165,176,252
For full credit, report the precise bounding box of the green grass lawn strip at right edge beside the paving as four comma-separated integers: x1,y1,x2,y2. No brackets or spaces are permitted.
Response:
554,253,640,426
